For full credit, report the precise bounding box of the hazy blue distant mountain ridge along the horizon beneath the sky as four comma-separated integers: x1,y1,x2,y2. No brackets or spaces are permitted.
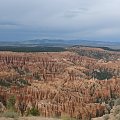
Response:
0,39,120,49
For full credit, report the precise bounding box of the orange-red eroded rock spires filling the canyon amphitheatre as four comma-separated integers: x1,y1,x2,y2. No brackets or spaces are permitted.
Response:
0,49,120,120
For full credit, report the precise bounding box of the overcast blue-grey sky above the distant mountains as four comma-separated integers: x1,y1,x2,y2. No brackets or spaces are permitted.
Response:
0,0,120,41
